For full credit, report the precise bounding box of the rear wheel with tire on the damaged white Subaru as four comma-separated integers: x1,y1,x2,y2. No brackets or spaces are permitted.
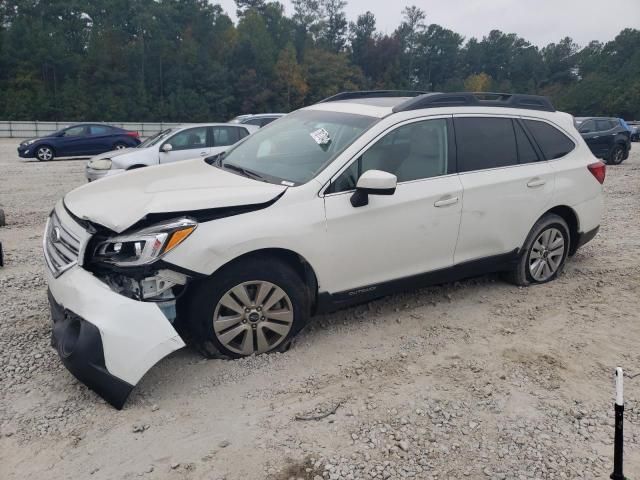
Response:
507,213,571,286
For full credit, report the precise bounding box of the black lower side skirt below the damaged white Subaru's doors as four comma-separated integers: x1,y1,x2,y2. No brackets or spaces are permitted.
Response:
315,248,520,314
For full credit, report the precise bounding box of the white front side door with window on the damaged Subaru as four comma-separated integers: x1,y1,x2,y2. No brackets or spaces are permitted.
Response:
325,118,462,296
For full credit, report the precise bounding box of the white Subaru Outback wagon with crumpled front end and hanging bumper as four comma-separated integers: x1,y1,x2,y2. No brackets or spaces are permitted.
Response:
44,91,605,408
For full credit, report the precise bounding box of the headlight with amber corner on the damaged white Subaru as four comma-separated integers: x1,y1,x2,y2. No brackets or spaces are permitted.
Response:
93,218,198,267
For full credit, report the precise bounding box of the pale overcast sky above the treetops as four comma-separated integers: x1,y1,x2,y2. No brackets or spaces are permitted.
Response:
212,0,640,46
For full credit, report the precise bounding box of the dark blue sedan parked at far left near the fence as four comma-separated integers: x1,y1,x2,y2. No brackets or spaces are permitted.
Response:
18,123,140,162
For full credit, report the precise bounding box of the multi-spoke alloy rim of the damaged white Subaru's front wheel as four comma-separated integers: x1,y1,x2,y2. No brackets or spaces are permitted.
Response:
213,280,293,355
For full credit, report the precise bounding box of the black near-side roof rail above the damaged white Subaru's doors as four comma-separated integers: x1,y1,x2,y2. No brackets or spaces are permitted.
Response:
393,92,556,113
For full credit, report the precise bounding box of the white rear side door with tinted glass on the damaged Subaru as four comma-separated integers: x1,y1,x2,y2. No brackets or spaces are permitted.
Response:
454,115,554,264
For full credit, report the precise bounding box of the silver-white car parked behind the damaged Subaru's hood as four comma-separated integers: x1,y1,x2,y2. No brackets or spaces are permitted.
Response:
86,123,259,182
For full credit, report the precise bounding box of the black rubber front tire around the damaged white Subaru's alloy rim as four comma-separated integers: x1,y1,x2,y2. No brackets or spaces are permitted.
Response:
188,258,310,358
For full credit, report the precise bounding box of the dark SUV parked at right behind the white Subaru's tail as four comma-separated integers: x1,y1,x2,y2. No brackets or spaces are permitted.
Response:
575,117,631,165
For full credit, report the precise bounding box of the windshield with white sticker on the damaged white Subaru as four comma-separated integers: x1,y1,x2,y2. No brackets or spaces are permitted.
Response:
221,110,378,186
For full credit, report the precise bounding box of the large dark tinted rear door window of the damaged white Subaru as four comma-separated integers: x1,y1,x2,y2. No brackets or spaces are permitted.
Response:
454,117,518,172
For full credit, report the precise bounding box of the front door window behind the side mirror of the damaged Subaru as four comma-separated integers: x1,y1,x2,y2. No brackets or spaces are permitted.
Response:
328,119,449,193
